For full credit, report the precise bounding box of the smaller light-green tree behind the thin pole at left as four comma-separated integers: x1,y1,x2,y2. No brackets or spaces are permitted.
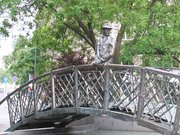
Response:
4,36,56,83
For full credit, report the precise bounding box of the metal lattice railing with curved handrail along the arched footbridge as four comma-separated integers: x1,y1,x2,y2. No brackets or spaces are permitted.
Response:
0,64,180,135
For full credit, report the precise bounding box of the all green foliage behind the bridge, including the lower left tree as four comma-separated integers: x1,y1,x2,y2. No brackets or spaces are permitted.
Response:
0,0,180,82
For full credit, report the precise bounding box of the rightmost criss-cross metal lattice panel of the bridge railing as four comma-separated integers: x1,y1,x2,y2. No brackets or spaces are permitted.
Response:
143,70,180,126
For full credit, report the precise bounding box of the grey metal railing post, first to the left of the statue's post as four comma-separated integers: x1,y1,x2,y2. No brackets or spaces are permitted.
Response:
74,67,80,109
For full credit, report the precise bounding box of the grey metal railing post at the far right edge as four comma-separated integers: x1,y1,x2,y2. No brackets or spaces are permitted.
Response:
172,92,180,135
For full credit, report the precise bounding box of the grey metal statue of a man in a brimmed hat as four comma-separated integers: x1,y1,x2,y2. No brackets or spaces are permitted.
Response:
95,23,114,63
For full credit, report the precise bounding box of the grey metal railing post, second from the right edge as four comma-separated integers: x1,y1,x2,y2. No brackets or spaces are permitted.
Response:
137,68,145,119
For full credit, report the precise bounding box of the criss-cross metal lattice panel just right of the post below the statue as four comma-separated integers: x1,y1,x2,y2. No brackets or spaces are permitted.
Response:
109,69,140,113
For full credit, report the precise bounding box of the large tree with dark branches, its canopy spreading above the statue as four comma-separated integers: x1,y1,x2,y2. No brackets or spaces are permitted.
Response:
2,0,180,68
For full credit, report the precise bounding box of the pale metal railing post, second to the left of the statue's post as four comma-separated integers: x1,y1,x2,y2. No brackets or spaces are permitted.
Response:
51,73,56,109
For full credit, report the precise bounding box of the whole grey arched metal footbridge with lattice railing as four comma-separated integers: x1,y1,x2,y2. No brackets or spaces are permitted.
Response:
0,64,180,135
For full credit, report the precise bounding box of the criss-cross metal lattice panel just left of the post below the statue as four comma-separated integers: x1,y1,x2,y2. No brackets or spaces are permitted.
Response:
78,70,104,108
